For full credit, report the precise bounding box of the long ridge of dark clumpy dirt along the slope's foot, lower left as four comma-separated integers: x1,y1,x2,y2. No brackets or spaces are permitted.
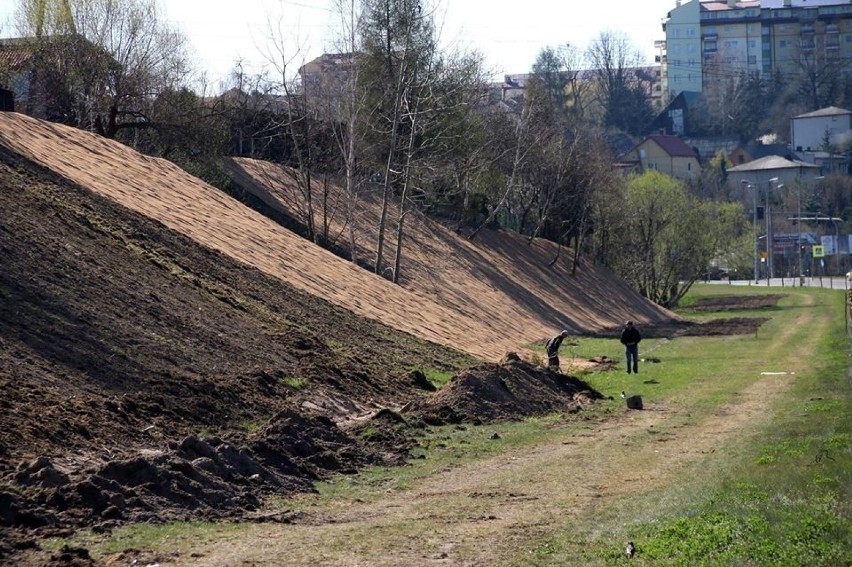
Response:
0,404,420,558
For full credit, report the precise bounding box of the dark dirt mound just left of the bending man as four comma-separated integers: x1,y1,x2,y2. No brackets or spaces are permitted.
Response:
410,356,603,424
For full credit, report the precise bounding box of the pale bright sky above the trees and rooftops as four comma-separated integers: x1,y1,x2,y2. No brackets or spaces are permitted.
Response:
0,0,675,89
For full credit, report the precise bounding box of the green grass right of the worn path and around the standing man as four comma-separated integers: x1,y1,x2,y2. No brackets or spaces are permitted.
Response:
511,286,852,567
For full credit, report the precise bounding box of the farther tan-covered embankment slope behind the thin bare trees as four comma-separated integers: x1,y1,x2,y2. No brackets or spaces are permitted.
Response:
227,158,677,345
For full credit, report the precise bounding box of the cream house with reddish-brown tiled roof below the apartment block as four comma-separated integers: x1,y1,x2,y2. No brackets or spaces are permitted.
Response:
618,135,701,180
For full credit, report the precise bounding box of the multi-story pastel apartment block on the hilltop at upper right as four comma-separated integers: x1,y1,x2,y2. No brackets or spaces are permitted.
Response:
656,0,852,99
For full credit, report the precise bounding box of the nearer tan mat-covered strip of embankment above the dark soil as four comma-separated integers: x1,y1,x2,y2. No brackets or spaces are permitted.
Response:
0,113,510,360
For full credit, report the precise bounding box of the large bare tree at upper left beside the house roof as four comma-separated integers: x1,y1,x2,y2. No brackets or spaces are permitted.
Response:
18,0,190,138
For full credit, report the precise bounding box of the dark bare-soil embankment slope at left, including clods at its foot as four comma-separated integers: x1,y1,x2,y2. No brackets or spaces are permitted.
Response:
0,144,486,544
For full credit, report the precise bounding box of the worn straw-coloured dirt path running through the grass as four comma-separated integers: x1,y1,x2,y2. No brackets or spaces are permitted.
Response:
168,376,791,565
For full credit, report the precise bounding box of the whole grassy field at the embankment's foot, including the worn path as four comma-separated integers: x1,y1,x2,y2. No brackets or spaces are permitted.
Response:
57,285,852,567
